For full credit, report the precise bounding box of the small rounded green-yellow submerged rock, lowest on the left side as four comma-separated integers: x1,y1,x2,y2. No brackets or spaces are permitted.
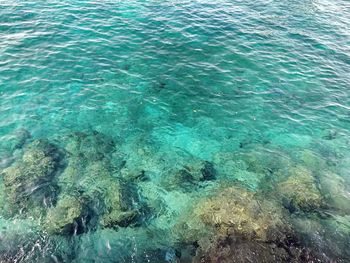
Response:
45,196,84,234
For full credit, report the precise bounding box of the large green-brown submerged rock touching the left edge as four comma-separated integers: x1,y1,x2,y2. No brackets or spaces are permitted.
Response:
2,140,62,217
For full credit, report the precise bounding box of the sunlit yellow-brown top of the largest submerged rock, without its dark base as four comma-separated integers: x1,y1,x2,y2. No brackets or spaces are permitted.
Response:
194,187,288,242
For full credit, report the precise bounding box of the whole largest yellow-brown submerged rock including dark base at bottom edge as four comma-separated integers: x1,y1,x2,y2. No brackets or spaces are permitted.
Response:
175,186,317,263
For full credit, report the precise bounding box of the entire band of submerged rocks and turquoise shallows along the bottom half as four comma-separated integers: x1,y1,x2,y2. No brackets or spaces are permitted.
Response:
0,131,350,262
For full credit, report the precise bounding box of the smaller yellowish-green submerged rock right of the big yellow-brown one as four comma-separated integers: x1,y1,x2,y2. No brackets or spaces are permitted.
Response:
277,166,324,212
